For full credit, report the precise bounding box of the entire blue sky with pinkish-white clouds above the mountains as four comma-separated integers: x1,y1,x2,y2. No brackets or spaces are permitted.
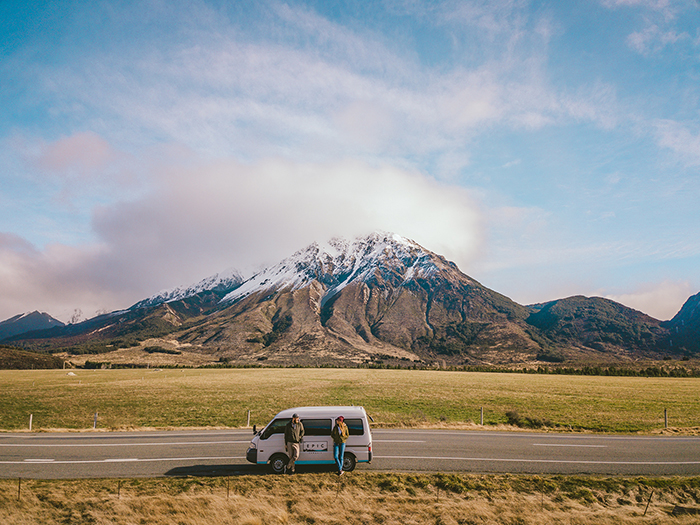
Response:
0,0,700,322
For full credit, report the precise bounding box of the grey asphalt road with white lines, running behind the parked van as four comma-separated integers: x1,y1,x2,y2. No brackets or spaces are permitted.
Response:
0,430,700,479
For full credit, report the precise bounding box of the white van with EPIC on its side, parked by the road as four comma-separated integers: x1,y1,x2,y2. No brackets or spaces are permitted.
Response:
246,406,372,474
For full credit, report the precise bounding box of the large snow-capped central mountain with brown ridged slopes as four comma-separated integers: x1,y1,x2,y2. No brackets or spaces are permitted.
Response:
168,233,534,362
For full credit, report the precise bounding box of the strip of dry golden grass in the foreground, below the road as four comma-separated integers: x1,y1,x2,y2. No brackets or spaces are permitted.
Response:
0,473,700,525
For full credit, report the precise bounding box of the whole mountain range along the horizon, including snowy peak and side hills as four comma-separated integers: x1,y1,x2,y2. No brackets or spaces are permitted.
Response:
7,233,700,366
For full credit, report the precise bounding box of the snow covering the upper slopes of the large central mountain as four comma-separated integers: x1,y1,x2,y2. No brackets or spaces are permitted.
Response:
221,232,446,302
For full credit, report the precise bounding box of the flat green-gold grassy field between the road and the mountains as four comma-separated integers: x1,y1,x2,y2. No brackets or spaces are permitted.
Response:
0,368,700,433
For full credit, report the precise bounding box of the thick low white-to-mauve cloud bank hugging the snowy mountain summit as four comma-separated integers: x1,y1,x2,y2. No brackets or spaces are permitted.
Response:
0,154,481,320
